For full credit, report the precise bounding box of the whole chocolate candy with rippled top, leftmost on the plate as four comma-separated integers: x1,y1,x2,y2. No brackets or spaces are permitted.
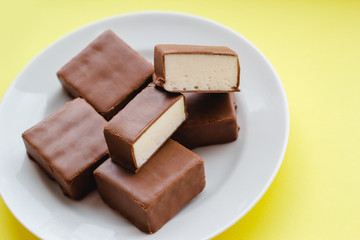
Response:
22,98,108,199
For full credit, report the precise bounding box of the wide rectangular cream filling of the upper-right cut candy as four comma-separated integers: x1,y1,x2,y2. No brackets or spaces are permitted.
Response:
164,54,238,91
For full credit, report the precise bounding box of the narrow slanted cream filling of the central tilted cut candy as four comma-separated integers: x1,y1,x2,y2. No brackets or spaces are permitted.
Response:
133,96,186,167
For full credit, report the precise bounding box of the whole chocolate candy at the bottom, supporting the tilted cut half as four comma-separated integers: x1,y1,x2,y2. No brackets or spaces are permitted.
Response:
94,139,205,233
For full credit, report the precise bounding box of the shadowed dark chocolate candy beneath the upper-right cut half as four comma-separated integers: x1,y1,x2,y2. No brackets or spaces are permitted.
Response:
172,93,239,149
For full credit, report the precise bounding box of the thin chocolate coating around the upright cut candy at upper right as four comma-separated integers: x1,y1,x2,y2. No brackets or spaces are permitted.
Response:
152,44,240,93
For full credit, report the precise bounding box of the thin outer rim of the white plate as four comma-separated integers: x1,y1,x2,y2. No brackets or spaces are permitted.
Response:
0,11,290,239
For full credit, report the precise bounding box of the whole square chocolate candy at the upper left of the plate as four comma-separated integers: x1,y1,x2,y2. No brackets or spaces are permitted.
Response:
57,30,154,120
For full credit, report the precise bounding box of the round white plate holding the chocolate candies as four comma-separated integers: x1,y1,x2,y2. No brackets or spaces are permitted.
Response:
0,12,289,239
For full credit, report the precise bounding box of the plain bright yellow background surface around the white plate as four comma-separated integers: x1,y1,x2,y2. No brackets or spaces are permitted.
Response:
0,0,360,240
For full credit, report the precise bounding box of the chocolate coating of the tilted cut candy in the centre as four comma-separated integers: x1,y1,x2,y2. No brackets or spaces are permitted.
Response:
104,84,186,172
